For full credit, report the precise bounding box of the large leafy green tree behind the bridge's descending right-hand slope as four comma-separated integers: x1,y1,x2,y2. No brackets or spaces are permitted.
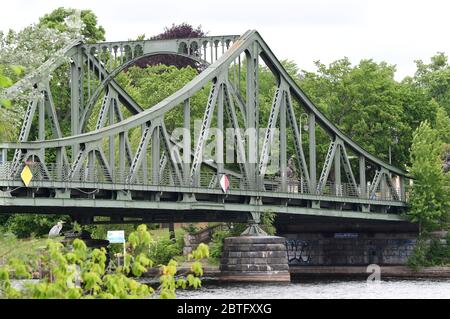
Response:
298,58,436,166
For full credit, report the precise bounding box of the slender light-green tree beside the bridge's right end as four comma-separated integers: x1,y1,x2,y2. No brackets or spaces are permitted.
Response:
408,121,450,234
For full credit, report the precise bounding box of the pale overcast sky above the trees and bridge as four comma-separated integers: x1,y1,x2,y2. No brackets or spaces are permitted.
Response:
0,0,450,79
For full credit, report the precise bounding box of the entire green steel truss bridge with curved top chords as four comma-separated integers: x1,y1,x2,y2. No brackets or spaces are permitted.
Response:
0,31,407,228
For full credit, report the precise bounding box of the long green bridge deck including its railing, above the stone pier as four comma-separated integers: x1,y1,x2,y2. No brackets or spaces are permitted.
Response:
0,163,406,221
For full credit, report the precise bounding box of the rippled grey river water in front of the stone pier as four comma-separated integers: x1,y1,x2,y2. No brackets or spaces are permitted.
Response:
177,279,450,299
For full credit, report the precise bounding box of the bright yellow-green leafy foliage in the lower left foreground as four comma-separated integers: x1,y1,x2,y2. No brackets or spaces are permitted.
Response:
0,225,209,299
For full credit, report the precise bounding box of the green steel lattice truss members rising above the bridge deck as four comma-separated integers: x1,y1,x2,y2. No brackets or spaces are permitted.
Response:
0,31,407,221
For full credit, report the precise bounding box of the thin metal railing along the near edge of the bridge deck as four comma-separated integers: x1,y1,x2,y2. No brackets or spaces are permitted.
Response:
0,162,407,201
